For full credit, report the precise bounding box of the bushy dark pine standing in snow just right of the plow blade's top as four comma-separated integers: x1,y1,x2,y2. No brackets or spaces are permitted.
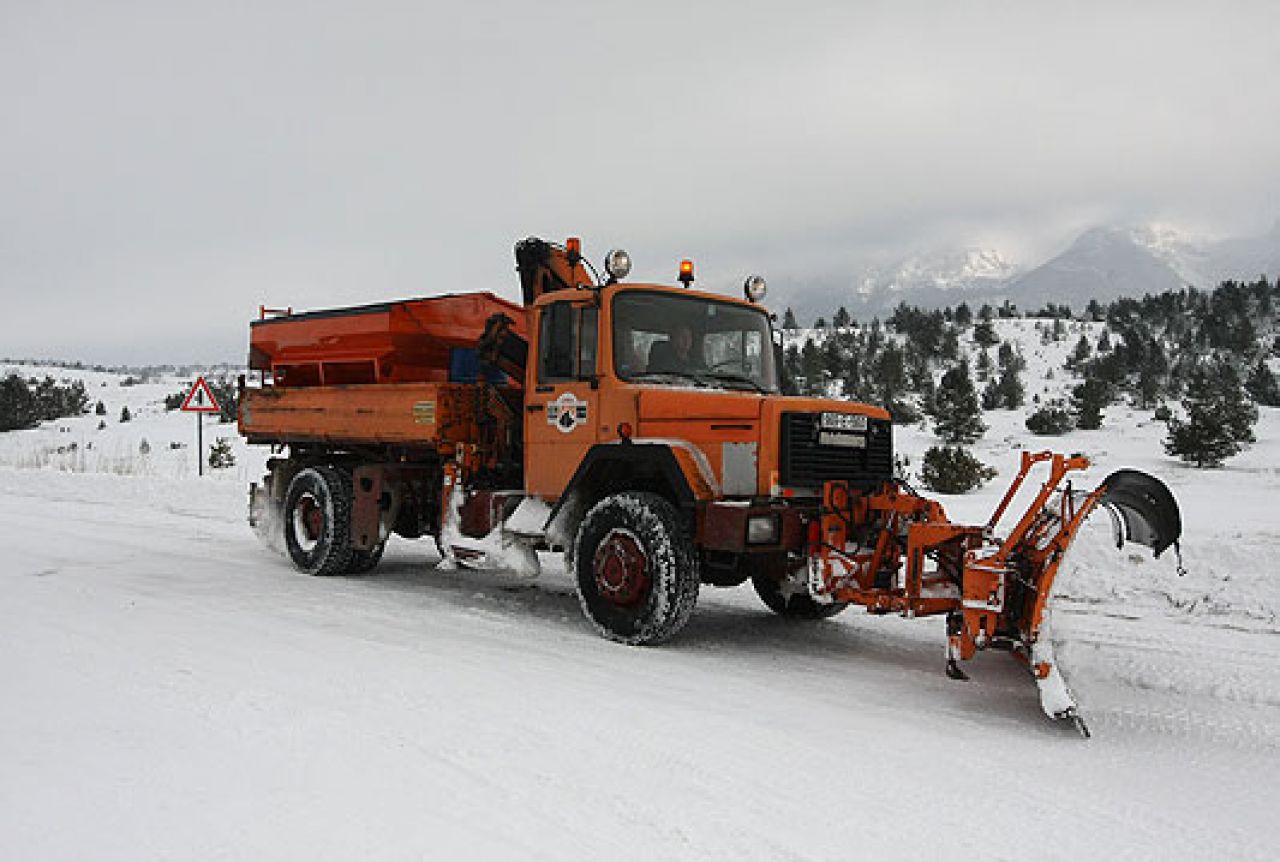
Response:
1165,359,1258,468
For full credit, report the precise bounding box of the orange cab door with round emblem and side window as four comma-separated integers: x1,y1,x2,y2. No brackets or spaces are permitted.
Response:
525,300,600,500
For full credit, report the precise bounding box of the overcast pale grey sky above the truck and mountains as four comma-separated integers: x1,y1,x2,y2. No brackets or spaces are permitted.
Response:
0,0,1280,362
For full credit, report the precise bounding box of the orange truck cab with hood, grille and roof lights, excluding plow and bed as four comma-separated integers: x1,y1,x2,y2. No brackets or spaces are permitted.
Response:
506,240,893,634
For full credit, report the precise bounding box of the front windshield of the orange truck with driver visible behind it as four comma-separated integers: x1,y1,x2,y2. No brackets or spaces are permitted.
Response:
613,291,778,392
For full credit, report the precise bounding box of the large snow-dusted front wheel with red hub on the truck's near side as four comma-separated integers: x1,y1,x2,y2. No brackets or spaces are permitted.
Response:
573,492,699,646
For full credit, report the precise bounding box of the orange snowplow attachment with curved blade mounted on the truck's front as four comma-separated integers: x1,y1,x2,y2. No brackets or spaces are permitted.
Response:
808,452,1181,735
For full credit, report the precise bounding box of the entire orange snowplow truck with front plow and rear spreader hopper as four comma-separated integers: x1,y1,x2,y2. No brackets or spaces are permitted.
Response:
239,238,1181,728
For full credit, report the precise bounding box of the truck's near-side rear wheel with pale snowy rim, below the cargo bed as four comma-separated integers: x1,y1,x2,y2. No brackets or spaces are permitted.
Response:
284,466,352,575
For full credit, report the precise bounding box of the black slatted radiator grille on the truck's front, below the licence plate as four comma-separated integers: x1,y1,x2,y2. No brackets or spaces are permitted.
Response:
778,412,893,488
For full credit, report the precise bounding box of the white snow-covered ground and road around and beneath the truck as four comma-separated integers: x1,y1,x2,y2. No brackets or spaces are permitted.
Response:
0,353,1280,861
